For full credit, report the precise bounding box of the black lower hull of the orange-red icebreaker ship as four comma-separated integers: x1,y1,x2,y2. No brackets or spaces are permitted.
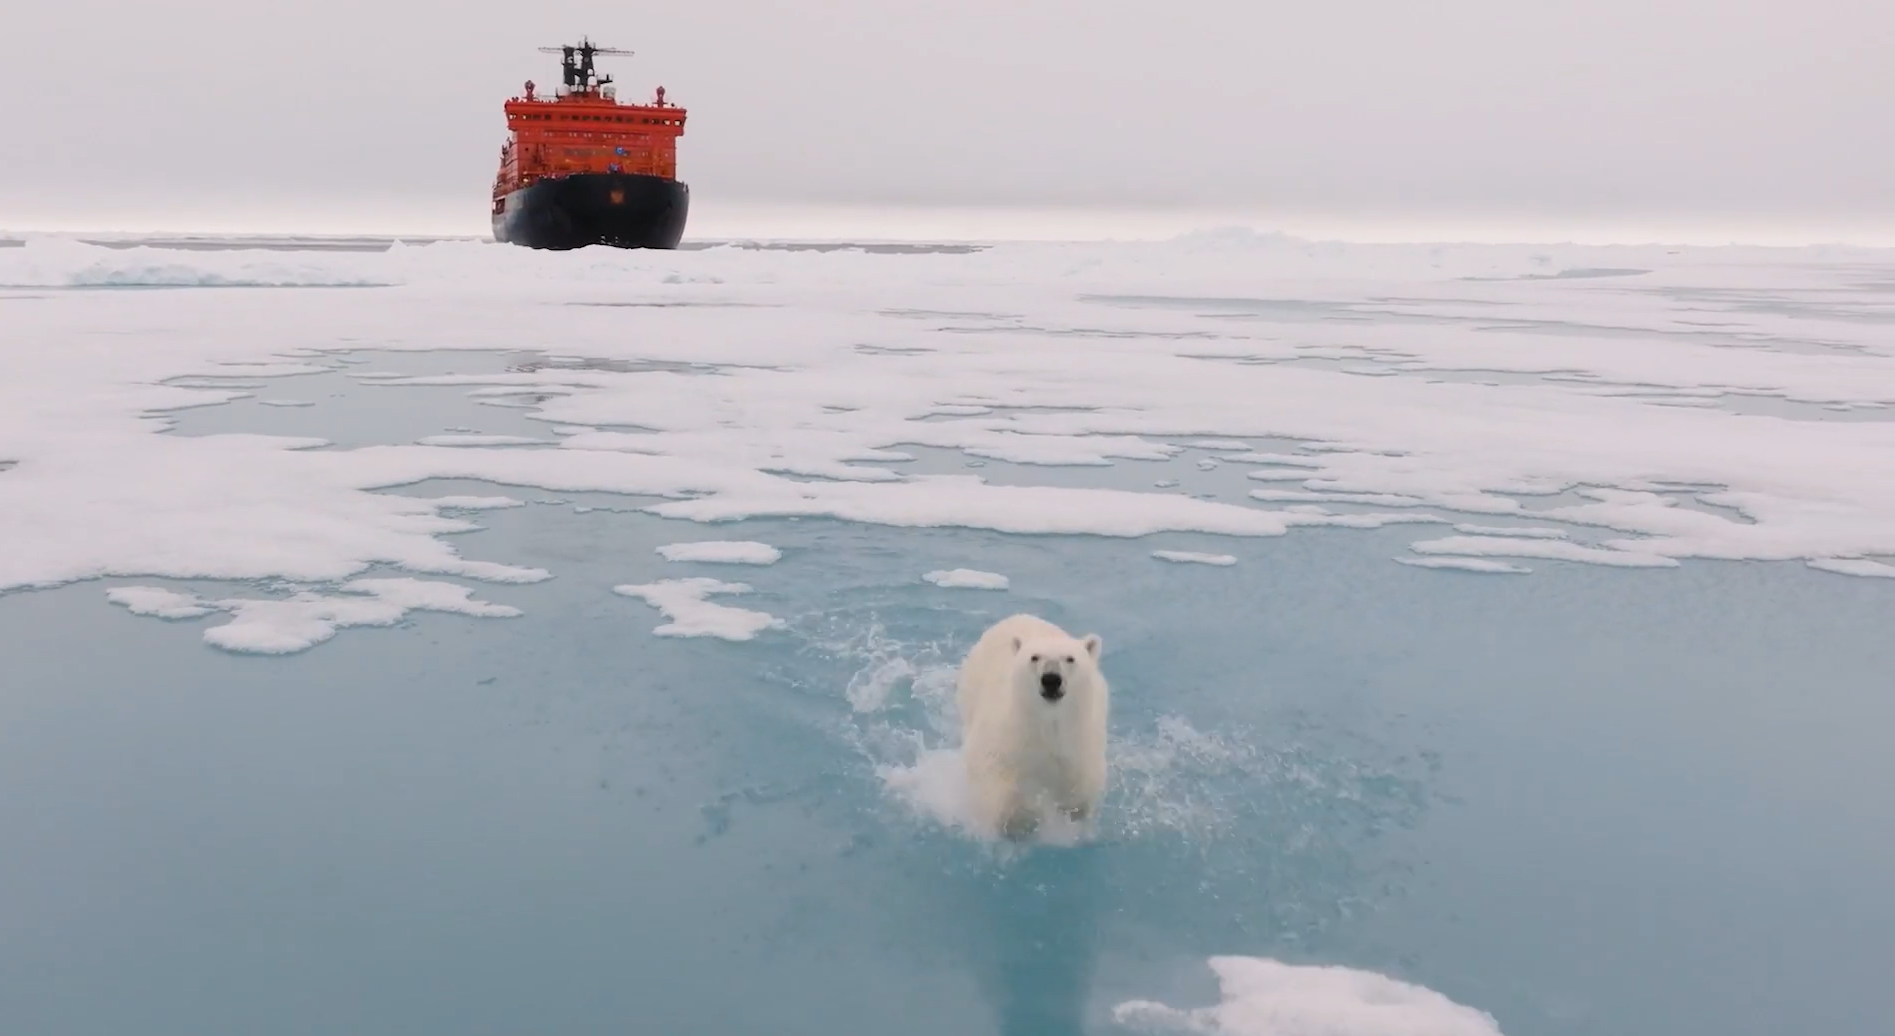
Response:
493,172,692,250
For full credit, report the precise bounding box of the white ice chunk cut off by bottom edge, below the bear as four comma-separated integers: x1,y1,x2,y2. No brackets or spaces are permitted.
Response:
1112,956,1501,1036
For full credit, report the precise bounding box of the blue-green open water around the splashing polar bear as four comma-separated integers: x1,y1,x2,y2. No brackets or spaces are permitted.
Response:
0,364,1895,1036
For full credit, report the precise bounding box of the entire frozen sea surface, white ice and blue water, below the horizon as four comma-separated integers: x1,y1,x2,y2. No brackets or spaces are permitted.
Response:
0,237,1895,1036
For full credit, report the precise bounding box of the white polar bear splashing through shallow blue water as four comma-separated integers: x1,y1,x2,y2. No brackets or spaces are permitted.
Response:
957,616,1110,839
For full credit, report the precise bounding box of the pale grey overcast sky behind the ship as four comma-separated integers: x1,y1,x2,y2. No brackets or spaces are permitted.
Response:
0,0,1895,237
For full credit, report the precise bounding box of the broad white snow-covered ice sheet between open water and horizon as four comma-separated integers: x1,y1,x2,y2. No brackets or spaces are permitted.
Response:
0,233,1895,647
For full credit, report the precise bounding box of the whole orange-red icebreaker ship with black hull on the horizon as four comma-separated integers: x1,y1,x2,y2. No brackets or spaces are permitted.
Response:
493,40,692,248
